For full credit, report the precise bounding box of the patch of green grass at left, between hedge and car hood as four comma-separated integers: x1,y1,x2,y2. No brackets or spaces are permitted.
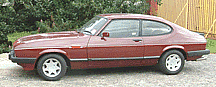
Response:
7,31,31,43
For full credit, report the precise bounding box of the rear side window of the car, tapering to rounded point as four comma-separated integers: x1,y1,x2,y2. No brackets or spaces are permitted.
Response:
142,20,172,36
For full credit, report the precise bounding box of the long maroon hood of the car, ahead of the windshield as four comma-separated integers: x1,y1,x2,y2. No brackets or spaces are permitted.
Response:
13,31,89,48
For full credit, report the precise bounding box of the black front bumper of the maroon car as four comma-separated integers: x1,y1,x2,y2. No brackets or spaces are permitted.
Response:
9,49,37,63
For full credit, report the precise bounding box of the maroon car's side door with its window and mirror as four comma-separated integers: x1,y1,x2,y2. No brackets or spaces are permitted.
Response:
88,19,144,68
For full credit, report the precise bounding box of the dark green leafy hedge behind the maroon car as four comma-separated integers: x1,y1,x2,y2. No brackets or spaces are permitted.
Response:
0,0,161,53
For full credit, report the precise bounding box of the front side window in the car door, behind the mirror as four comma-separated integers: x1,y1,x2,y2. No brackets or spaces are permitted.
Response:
100,19,139,38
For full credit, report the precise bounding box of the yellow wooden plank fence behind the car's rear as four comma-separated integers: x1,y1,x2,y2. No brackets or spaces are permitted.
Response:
158,0,216,39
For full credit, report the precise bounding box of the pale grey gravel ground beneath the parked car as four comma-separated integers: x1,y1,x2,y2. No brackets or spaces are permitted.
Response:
0,54,216,87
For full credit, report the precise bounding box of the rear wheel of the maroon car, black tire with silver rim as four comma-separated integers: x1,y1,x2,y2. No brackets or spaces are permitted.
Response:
158,50,185,75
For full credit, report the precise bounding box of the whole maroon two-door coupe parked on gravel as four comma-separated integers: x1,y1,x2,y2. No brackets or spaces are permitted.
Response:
9,14,210,80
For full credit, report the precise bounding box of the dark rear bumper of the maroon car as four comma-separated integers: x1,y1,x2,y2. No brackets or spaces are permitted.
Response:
187,49,210,57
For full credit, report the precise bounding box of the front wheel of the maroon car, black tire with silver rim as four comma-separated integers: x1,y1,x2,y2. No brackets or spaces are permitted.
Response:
37,54,67,81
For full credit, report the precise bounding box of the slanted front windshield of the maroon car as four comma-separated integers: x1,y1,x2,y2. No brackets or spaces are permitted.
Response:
78,16,107,35
